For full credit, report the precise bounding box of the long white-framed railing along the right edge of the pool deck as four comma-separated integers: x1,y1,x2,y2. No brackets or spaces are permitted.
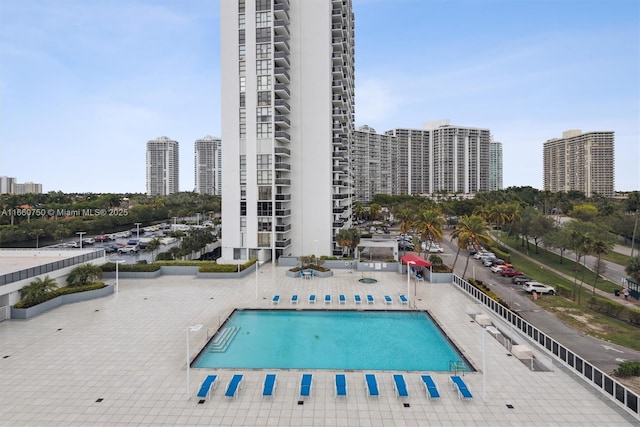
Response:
453,274,640,419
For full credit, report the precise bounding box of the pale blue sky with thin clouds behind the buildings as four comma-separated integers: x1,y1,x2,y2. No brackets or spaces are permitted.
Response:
0,0,640,192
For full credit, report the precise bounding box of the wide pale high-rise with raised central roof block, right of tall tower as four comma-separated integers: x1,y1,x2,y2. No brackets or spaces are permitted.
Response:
385,120,491,194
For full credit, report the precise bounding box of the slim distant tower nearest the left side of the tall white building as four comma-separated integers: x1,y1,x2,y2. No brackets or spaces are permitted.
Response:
194,135,222,195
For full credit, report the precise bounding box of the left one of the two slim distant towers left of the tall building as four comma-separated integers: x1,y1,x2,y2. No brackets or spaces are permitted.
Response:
147,136,180,196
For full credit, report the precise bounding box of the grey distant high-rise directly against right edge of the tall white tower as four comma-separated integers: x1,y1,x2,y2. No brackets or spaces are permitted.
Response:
352,125,398,203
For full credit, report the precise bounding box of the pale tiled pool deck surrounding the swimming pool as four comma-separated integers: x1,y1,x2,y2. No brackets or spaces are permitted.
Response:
0,264,638,427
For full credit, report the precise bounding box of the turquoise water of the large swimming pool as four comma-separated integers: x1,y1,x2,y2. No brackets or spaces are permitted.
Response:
192,310,468,371
